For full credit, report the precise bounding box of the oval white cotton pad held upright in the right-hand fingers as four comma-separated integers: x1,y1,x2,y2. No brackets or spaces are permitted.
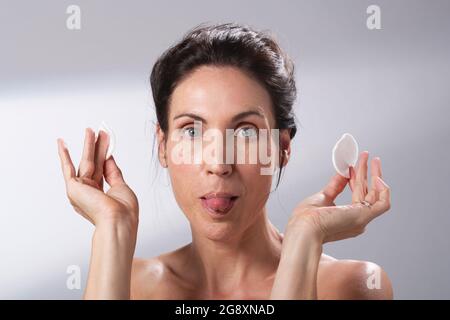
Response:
332,133,359,178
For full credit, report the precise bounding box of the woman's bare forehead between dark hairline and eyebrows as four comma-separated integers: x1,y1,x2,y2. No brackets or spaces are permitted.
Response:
169,66,273,124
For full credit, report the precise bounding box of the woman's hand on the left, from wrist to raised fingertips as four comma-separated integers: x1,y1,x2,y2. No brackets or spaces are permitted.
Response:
57,128,139,228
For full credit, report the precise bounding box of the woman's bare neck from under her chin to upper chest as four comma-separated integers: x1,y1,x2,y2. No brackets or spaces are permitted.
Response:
189,208,281,295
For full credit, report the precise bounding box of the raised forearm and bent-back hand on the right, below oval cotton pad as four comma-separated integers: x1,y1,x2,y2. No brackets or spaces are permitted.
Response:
271,151,390,299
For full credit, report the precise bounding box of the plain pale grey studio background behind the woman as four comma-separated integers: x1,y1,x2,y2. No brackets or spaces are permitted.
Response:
0,0,450,299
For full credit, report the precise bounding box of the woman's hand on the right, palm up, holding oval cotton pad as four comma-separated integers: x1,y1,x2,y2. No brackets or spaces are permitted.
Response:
285,151,391,243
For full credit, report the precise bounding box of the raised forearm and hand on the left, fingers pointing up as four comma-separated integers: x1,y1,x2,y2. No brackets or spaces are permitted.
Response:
57,128,139,299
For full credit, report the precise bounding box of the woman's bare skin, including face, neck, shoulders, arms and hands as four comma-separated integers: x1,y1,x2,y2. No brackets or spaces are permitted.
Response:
58,67,393,299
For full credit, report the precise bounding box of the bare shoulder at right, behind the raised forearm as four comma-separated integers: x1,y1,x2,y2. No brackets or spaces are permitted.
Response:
317,254,393,300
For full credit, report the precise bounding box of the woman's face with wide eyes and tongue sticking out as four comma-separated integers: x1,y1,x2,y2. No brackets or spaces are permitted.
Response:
157,66,290,240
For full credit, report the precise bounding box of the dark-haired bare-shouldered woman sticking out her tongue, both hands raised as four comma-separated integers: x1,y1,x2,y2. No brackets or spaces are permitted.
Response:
58,24,392,299
